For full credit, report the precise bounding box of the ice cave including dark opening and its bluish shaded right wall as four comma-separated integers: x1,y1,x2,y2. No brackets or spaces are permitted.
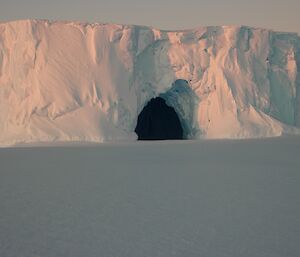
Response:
135,79,196,140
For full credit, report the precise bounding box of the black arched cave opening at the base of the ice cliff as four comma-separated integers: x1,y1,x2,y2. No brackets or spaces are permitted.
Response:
135,97,183,140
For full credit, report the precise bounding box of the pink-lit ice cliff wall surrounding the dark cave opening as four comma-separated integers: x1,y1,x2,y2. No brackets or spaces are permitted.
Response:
0,20,300,145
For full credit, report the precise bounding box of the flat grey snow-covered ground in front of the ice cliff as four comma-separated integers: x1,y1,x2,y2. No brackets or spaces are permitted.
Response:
0,137,300,257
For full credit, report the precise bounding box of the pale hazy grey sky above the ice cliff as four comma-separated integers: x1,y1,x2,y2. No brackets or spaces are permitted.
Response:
0,0,300,34
